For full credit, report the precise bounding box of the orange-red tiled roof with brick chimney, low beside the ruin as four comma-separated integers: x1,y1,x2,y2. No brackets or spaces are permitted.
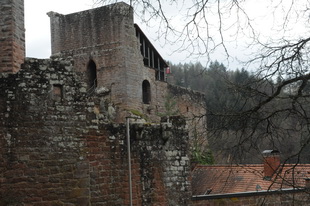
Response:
192,164,310,196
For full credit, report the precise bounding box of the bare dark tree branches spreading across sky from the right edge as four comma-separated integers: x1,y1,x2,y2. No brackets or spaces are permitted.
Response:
94,0,310,195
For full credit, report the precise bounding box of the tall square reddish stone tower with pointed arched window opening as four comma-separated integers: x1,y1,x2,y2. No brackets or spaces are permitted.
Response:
48,3,162,122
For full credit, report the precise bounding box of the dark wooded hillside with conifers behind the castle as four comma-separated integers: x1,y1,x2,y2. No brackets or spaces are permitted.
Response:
168,61,310,163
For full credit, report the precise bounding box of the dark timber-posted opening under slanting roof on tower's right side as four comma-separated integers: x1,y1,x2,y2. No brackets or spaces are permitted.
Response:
135,24,168,81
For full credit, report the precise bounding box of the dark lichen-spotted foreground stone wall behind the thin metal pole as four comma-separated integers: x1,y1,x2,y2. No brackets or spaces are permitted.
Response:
0,58,191,205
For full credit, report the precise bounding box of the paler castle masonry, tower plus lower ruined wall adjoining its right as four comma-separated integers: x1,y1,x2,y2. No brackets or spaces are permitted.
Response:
49,3,205,125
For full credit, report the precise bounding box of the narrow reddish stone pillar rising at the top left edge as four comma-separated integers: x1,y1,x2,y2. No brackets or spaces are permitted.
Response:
0,0,25,73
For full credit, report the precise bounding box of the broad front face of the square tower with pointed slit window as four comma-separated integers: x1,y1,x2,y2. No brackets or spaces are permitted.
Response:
49,3,136,116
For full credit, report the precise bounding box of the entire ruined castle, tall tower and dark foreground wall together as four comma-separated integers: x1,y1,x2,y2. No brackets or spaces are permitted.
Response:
0,0,204,205
